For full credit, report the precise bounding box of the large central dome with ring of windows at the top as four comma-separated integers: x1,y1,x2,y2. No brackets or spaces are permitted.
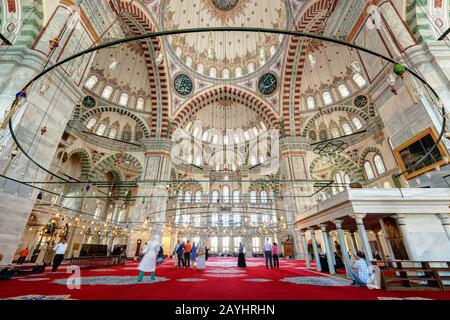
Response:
162,0,288,79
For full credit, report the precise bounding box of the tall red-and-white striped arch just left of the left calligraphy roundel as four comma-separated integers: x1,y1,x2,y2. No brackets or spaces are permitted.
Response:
115,0,170,138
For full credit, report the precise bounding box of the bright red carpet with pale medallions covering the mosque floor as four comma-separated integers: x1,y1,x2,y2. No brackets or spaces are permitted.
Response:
0,258,450,300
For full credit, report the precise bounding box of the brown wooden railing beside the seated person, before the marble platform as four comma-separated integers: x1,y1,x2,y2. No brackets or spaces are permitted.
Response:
378,260,450,291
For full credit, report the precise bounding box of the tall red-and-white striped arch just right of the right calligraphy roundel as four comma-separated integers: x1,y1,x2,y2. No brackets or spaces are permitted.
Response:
281,0,337,136
